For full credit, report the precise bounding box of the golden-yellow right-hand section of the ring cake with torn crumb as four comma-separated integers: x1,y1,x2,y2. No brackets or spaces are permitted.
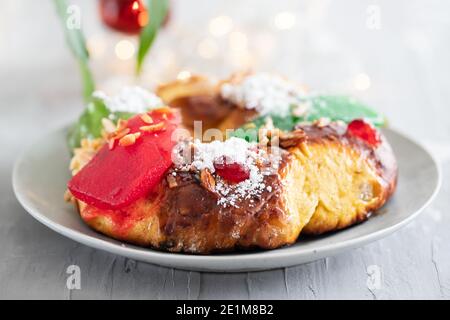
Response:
298,123,398,235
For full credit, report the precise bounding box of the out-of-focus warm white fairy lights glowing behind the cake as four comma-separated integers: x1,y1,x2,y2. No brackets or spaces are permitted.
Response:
87,5,371,91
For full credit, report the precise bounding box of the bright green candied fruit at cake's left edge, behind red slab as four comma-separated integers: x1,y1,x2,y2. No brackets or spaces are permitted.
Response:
67,98,111,150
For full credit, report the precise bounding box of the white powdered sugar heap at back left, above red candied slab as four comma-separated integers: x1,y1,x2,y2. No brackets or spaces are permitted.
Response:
94,87,164,113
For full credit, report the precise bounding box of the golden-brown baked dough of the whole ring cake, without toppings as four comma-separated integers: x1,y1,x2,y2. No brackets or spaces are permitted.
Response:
69,77,397,254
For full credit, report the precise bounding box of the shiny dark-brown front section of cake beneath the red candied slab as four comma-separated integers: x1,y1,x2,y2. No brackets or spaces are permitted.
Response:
76,152,313,254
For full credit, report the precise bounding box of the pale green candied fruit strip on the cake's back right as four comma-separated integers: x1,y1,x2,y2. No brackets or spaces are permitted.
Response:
301,95,386,127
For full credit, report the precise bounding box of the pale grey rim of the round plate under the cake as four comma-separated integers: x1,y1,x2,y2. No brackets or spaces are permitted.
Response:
12,127,442,273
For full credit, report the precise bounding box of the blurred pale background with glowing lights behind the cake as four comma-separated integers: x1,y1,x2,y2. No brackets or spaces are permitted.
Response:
0,0,450,146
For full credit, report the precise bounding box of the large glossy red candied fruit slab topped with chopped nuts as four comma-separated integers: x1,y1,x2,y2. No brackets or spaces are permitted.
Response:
68,110,181,210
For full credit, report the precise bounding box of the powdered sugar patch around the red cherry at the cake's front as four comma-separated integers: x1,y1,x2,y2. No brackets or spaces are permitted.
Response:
174,138,282,207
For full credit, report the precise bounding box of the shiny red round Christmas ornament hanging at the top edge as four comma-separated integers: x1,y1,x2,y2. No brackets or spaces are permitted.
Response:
100,0,148,34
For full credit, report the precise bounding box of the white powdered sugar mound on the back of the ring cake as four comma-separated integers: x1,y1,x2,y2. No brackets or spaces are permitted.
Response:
221,73,304,116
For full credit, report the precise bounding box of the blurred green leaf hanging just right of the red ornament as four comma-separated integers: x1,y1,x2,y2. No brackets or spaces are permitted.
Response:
136,0,169,74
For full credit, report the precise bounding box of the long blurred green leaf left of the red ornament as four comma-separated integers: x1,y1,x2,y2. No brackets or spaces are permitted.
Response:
53,0,95,101
